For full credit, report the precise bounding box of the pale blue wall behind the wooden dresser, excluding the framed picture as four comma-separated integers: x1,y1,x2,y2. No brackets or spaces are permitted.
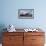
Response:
0,0,46,31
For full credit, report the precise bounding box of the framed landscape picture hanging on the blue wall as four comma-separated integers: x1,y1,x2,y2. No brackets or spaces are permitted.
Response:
18,9,34,19
